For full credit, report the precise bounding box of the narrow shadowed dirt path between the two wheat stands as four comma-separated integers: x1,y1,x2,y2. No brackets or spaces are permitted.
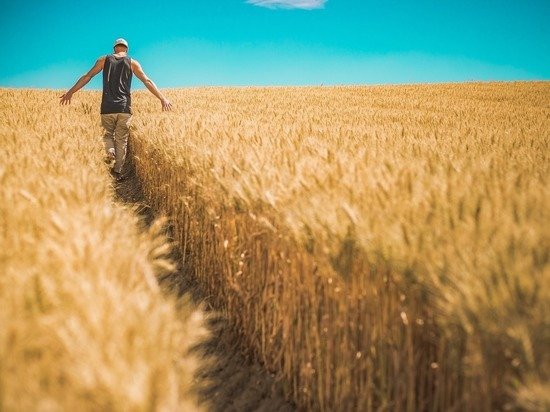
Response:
116,162,296,412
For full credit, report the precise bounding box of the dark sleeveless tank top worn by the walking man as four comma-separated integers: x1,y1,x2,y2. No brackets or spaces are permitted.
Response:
101,54,132,114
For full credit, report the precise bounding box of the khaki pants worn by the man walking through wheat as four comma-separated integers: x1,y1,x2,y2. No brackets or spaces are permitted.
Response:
101,113,132,173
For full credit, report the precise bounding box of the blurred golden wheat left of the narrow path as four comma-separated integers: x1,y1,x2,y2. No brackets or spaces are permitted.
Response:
0,89,209,411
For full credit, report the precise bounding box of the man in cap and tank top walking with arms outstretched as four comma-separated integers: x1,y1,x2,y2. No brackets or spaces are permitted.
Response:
60,39,172,182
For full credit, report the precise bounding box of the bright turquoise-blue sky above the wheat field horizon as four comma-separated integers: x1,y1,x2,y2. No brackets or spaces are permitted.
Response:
0,0,550,89
